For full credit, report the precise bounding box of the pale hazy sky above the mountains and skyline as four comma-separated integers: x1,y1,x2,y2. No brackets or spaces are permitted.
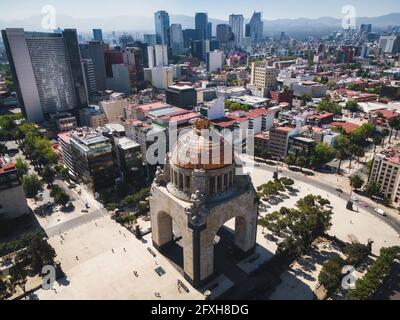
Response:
0,0,400,20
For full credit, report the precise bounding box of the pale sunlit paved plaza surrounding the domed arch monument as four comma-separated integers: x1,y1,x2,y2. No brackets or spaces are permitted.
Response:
31,168,400,300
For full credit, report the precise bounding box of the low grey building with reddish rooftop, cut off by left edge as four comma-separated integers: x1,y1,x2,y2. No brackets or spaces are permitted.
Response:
0,157,30,221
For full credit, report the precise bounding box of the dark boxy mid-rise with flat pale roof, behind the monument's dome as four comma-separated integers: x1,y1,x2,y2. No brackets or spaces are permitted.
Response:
165,85,197,110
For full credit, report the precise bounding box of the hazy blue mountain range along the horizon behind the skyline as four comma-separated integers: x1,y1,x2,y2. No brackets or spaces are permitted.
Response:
0,13,400,34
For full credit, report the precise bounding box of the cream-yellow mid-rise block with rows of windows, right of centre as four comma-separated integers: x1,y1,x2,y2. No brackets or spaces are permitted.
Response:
250,62,279,90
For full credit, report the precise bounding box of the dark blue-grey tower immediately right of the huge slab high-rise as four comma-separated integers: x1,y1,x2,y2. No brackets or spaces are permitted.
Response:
79,41,106,90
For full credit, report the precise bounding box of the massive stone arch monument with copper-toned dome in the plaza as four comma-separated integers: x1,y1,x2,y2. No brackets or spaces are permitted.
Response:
150,120,258,288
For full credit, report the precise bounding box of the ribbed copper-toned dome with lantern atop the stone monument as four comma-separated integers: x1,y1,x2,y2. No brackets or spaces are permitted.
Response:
171,119,234,170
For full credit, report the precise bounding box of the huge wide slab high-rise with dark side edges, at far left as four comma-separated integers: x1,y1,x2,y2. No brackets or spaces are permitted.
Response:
2,29,87,123
